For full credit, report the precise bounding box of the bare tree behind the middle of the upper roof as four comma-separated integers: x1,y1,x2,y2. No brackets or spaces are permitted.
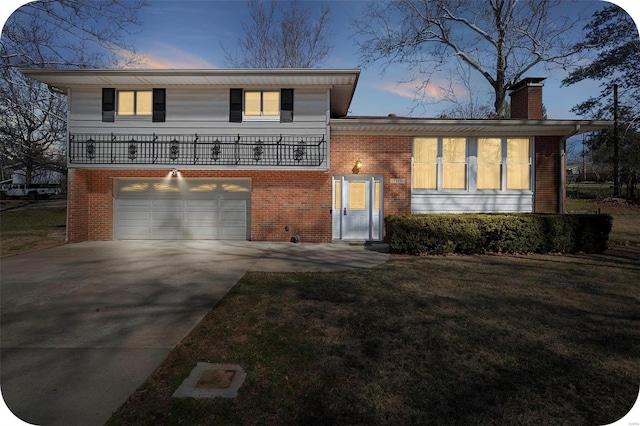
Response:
223,0,333,68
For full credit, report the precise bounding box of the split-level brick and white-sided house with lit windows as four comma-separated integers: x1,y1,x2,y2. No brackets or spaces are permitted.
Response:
23,69,610,242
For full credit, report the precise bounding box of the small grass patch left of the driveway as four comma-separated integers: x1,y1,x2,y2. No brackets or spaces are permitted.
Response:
0,207,67,257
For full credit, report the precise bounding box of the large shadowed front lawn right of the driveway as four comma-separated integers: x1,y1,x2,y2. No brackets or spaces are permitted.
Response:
109,247,640,425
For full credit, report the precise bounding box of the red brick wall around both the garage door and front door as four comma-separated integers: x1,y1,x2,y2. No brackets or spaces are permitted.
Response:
68,136,411,242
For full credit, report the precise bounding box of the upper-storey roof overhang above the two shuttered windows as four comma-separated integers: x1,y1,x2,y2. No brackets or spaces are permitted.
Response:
21,69,360,117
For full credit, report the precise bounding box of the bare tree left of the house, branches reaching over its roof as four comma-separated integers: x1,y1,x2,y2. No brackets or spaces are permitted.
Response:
0,0,145,183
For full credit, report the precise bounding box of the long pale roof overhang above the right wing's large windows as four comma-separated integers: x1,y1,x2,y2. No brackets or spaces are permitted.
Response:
330,117,613,137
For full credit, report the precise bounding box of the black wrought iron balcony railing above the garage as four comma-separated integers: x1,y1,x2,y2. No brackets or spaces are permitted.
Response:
69,133,327,167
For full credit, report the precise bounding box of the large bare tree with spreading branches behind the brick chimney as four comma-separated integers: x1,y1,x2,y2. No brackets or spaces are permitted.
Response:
353,0,584,117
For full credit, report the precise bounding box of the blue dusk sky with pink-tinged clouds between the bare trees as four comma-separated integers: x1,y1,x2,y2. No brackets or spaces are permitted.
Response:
0,0,640,119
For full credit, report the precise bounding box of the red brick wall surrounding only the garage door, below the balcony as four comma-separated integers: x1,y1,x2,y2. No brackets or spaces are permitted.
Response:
68,168,331,242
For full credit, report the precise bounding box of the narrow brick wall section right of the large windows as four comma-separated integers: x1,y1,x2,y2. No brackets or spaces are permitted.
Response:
533,136,562,213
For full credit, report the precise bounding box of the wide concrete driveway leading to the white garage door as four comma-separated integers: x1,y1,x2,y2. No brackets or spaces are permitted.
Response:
0,241,388,425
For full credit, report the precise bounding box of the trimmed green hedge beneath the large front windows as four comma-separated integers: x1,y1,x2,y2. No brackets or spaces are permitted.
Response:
385,213,613,255
